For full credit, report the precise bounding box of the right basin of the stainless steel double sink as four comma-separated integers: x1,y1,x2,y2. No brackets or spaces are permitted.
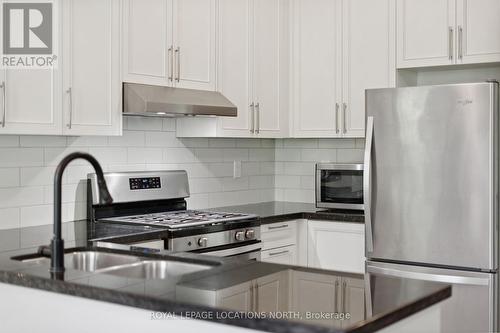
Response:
106,260,212,280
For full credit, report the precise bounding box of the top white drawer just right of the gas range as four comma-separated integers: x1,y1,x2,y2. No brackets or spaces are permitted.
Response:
261,221,297,250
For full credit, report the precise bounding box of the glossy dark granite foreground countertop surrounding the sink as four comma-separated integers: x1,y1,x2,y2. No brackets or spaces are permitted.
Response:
0,240,451,333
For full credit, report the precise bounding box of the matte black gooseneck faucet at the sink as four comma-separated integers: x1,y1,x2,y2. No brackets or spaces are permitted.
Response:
50,152,113,274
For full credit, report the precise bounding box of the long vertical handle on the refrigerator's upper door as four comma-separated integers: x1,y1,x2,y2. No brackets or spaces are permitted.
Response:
363,117,373,253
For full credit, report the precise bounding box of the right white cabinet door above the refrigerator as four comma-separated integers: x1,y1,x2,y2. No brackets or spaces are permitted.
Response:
457,0,500,64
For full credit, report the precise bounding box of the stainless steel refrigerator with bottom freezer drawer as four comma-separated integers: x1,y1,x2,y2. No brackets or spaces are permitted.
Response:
364,82,499,333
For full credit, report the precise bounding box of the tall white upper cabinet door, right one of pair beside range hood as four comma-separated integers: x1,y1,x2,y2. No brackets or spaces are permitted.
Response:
253,0,283,137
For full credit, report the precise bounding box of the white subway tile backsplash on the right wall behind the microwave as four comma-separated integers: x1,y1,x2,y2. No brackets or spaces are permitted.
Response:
275,139,365,202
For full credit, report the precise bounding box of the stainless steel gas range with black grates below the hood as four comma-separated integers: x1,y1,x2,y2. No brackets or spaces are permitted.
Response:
87,170,262,260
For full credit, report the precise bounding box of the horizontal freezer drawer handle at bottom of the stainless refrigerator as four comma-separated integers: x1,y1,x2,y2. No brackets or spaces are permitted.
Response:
367,265,490,286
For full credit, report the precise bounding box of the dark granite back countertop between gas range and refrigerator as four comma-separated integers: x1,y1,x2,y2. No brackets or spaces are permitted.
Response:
210,201,365,224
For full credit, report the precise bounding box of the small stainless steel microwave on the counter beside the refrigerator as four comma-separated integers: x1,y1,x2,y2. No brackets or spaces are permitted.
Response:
316,163,364,210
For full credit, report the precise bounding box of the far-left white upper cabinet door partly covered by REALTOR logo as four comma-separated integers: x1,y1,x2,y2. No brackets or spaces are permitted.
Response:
0,1,62,134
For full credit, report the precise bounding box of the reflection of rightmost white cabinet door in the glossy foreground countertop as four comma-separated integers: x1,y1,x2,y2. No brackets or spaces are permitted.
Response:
340,278,365,327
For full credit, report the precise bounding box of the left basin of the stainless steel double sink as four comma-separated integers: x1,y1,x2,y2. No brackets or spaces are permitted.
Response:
64,251,141,272
